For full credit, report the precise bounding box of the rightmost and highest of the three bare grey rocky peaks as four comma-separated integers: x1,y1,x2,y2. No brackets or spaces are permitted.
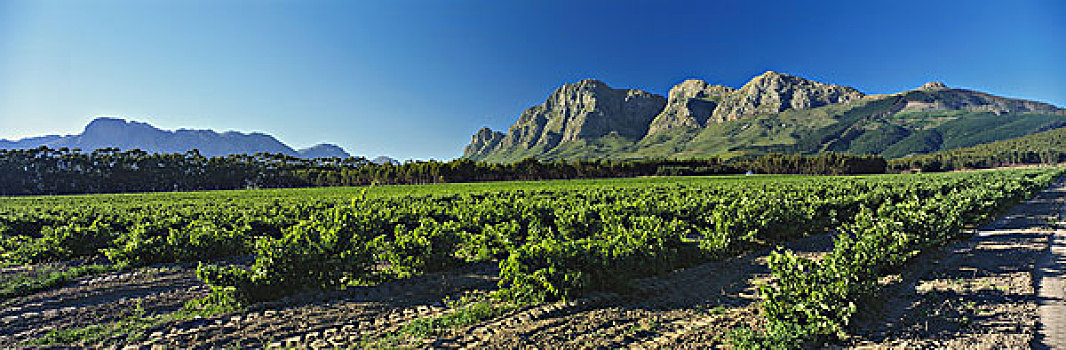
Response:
712,71,863,122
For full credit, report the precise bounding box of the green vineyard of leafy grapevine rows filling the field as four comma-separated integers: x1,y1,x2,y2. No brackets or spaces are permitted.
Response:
0,169,1063,348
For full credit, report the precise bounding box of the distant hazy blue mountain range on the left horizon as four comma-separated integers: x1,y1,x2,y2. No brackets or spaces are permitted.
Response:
0,117,350,158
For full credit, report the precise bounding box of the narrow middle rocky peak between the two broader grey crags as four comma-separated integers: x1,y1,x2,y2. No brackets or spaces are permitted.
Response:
648,79,736,134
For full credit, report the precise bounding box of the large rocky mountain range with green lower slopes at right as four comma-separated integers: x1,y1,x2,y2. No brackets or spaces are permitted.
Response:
464,71,1066,162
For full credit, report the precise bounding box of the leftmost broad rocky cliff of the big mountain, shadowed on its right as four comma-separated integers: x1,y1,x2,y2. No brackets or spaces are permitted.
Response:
466,80,666,156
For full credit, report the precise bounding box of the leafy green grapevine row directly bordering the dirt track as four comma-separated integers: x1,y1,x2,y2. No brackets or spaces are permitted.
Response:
760,170,1062,344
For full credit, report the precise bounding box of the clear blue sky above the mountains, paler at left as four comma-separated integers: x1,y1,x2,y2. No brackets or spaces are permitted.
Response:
0,0,1066,159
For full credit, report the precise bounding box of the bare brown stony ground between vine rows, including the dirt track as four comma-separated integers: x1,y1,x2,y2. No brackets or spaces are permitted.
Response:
0,181,1066,349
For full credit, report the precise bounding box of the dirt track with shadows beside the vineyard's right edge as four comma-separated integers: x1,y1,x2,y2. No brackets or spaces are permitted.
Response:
845,179,1066,349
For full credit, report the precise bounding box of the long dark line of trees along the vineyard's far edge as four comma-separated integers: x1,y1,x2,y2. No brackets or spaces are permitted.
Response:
0,147,886,195
